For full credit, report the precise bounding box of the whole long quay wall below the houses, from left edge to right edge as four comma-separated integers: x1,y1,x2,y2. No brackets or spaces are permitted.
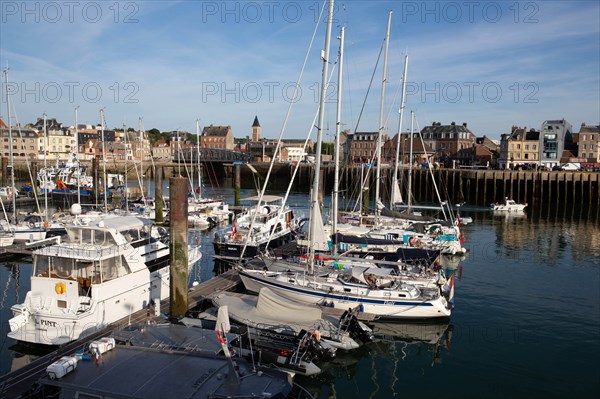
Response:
0,158,600,206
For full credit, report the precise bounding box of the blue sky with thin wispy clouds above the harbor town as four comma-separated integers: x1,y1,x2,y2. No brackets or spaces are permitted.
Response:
0,0,600,141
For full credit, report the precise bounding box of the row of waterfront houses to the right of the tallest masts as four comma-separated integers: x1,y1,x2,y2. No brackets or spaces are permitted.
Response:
344,119,600,169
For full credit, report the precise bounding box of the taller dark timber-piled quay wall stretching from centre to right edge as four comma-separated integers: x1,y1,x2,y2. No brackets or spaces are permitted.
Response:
225,164,600,206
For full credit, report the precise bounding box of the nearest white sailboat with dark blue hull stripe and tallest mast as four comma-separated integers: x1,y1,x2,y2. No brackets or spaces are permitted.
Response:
239,5,451,318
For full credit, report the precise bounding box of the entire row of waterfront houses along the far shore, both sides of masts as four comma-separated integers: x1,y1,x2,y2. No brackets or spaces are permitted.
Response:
0,116,600,169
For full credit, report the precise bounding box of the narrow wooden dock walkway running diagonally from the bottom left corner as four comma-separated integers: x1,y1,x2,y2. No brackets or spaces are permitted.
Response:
0,270,241,398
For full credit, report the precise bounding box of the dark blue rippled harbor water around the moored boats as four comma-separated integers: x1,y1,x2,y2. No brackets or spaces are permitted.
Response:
0,189,600,399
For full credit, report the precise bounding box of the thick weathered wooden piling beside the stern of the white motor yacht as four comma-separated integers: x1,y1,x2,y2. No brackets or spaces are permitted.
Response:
169,177,189,317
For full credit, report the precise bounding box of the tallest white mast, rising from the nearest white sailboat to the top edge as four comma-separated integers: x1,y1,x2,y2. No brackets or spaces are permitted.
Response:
308,0,334,270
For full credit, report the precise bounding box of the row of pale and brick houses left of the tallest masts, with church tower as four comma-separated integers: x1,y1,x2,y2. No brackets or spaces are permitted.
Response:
0,117,313,162
